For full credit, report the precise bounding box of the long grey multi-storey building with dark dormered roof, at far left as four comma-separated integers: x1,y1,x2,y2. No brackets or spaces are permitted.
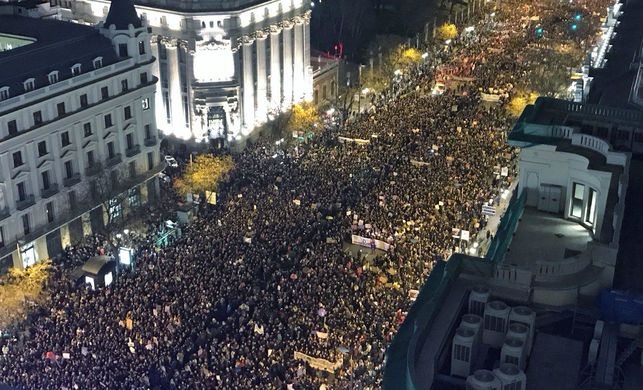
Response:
0,1,165,268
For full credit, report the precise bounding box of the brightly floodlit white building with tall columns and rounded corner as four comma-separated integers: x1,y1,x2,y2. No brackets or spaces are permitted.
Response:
65,0,312,141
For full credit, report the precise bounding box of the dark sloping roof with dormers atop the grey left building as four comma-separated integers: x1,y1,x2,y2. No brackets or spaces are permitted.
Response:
0,15,118,97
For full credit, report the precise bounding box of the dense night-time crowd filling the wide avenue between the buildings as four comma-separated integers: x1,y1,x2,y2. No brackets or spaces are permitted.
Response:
0,1,603,389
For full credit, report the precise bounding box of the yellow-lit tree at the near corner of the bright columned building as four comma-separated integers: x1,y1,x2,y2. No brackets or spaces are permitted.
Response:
174,154,234,200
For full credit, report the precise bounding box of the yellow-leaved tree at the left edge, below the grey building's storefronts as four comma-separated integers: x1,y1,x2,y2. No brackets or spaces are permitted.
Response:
0,261,51,329
